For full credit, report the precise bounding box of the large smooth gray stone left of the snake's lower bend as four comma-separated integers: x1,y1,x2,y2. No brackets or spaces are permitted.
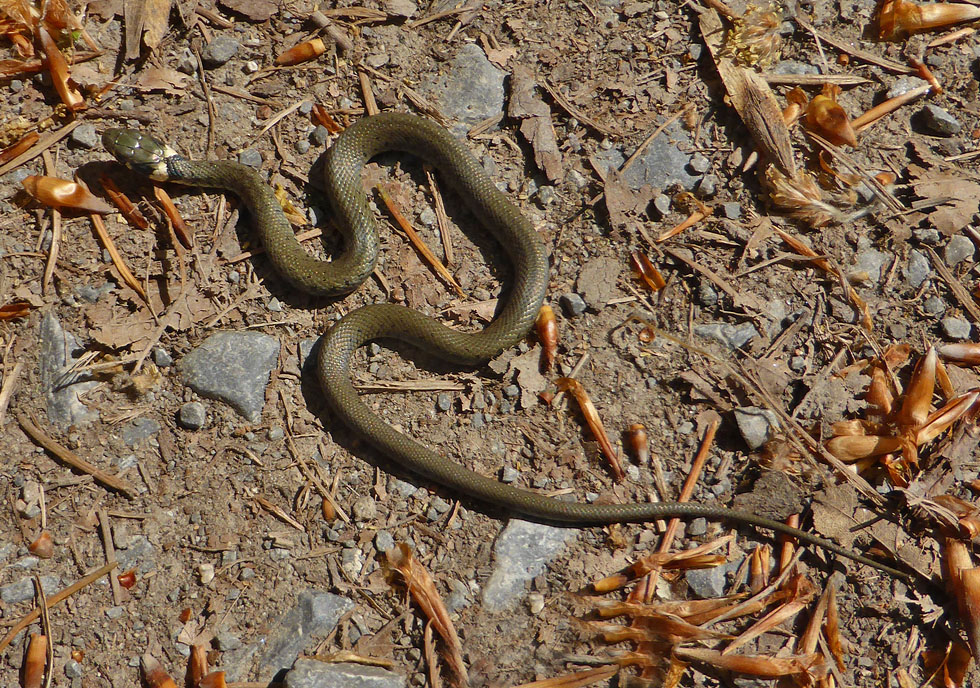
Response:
179,332,279,423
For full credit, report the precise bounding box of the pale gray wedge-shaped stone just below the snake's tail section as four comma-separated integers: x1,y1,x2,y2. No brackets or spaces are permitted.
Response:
483,519,578,613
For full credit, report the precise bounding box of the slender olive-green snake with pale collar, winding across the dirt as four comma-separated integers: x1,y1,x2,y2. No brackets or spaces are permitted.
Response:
102,112,909,579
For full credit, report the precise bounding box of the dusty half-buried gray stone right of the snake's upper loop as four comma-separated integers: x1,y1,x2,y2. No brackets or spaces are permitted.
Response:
594,122,701,191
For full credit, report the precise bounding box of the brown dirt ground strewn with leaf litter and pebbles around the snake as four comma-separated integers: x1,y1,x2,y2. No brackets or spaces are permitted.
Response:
0,0,980,688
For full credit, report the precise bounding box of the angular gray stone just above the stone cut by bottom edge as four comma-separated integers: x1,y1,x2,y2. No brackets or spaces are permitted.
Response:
256,590,354,676
